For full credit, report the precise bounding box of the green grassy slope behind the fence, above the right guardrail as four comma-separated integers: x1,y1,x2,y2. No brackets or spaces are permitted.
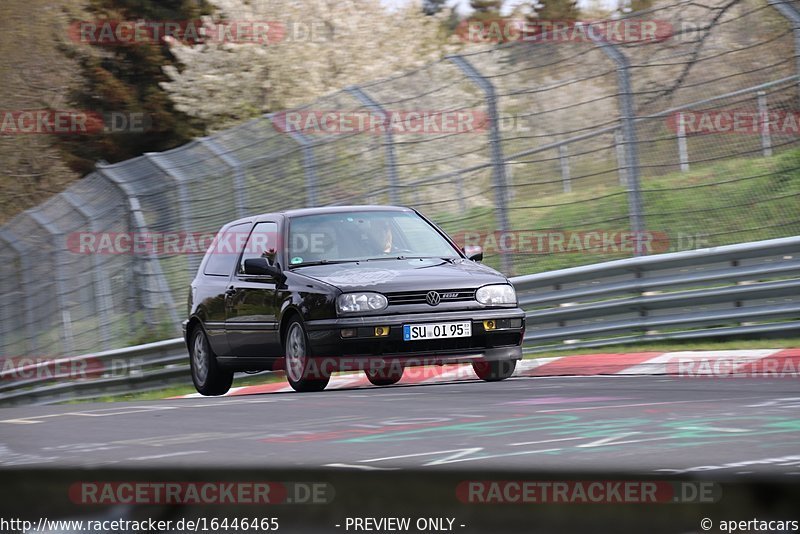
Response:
435,149,800,275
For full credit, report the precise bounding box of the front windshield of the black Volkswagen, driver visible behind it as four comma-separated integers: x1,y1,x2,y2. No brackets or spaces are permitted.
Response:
289,211,460,266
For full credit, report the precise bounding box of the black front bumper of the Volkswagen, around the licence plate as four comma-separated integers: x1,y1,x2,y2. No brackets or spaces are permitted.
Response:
306,308,525,366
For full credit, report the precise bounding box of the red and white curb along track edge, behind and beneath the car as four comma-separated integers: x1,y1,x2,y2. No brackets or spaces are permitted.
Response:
172,349,800,398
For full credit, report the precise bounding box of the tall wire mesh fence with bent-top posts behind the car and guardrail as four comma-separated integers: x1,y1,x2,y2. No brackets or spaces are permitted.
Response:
0,0,800,355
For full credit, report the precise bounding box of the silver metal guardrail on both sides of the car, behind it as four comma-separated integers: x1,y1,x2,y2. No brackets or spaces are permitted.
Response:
0,237,800,404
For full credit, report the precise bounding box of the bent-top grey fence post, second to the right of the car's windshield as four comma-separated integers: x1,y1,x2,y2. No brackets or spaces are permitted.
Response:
587,31,646,256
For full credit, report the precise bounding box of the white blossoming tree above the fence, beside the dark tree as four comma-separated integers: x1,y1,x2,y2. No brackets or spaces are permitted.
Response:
162,0,455,130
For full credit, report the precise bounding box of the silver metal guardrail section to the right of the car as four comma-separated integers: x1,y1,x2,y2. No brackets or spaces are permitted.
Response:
513,237,800,352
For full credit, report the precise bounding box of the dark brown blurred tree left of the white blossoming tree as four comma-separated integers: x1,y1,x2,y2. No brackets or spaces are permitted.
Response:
58,0,209,173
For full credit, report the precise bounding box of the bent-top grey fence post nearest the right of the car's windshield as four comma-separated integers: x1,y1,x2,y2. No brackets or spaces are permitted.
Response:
447,56,514,276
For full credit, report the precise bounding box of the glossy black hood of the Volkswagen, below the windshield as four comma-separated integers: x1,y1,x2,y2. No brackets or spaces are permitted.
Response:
292,258,506,293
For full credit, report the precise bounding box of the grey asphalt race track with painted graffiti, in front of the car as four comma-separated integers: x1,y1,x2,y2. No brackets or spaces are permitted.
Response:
0,376,800,474
